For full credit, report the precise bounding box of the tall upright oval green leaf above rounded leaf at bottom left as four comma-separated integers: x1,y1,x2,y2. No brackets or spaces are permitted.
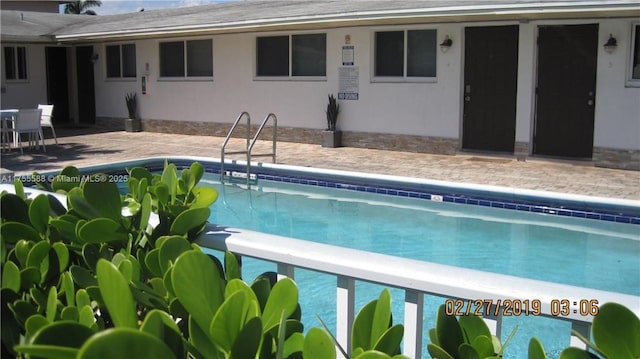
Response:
97,259,138,328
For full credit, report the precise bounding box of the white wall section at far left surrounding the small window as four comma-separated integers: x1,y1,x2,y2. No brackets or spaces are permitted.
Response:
0,43,47,108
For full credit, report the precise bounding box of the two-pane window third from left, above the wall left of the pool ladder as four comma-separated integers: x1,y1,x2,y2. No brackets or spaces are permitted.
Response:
160,40,213,77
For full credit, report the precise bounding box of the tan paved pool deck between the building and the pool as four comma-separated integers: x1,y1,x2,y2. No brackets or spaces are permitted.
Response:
0,128,640,201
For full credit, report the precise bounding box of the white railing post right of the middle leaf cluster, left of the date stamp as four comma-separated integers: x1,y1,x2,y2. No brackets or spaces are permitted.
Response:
403,289,424,359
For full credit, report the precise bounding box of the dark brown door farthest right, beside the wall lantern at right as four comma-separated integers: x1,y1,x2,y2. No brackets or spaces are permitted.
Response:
533,25,598,158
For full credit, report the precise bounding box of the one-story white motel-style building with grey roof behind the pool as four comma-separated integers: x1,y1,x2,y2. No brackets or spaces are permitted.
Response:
1,0,640,170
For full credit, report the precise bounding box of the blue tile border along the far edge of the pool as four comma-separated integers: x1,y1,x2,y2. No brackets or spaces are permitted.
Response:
51,159,640,225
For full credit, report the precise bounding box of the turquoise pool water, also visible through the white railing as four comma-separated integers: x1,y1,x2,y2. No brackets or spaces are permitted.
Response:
202,174,640,358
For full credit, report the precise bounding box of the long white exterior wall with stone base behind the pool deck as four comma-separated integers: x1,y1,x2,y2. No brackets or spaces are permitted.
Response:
95,19,640,172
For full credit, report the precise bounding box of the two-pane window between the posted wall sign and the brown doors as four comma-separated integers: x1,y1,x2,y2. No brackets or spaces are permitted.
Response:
374,30,437,78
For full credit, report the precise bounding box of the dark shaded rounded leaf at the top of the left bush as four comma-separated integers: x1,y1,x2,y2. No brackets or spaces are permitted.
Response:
82,178,122,221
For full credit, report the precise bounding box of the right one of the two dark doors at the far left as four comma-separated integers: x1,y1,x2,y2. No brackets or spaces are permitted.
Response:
76,46,96,124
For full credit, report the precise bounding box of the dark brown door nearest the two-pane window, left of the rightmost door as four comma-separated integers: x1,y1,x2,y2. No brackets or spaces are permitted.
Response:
462,26,518,153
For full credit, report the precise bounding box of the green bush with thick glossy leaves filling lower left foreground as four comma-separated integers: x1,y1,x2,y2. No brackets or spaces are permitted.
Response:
0,163,404,359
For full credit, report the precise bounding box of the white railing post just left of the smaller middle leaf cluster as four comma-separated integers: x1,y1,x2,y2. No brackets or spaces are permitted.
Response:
336,276,356,354
